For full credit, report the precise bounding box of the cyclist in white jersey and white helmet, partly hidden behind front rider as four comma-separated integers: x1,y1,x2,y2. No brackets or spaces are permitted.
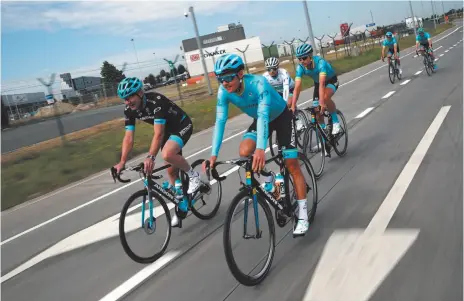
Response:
263,57,295,102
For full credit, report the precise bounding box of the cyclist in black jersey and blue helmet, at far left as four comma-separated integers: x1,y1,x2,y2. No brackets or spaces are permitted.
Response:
114,77,200,226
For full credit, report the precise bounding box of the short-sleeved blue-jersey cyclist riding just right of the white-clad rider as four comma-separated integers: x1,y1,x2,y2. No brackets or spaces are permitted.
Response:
292,44,341,135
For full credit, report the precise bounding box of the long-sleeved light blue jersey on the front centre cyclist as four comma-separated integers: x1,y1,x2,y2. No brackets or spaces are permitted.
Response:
211,74,287,156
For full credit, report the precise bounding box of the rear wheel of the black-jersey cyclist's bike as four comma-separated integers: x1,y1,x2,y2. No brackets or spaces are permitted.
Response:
190,159,222,220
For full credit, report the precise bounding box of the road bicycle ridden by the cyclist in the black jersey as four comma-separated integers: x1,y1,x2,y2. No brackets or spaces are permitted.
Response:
110,159,222,263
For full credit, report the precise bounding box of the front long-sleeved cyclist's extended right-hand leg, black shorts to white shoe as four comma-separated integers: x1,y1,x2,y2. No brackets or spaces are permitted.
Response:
270,108,309,235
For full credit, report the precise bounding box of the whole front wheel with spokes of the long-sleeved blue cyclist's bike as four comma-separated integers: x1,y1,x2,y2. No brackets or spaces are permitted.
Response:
223,190,275,286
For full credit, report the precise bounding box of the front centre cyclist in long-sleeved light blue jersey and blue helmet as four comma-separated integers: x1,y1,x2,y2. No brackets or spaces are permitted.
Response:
207,54,309,236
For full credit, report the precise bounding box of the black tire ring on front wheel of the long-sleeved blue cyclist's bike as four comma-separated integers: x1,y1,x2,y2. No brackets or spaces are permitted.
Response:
223,190,275,286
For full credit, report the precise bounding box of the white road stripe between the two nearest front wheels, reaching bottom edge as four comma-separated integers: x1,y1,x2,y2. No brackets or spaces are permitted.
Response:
100,251,181,301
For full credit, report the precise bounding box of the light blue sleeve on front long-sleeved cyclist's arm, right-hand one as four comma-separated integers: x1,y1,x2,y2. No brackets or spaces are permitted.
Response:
256,82,273,150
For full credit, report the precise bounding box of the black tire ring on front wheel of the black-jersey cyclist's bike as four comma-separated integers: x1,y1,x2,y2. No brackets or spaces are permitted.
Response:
119,189,171,263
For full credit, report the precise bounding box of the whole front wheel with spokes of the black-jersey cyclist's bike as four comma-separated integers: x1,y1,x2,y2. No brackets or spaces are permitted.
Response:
119,190,171,263
